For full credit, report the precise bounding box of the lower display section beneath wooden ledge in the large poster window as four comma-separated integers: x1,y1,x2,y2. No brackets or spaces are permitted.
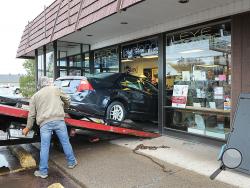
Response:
164,106,230,140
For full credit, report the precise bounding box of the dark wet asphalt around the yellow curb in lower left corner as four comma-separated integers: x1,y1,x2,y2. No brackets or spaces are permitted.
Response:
0,144,80,188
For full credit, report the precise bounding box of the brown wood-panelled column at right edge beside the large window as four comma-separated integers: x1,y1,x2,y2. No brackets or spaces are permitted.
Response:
231,12,250,122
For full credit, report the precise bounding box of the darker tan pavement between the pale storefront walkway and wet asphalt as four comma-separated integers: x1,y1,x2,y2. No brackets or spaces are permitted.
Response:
50,139,234,188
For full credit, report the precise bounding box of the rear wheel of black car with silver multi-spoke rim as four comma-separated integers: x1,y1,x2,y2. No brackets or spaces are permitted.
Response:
106,101,127,124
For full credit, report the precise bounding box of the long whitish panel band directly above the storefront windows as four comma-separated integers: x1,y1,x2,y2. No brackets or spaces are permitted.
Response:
91,0,250,49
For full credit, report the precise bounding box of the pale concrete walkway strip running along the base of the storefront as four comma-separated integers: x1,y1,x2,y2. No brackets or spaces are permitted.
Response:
111,136,250,188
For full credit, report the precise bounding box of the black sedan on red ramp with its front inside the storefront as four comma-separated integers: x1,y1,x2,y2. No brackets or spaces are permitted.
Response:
55,73,158,121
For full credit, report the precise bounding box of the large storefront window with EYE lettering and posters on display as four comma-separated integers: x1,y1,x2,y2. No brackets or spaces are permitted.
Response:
166,22,231,139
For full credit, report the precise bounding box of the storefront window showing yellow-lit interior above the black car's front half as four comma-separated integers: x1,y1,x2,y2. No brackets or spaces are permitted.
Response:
121,38,158,86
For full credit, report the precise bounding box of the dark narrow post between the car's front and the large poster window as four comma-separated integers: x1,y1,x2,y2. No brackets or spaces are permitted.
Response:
158,33,166,134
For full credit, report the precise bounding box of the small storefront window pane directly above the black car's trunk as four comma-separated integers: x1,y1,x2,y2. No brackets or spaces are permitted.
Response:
94,48,119,73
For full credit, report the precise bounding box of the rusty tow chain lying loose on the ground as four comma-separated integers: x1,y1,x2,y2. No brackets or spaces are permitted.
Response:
133,144,173,174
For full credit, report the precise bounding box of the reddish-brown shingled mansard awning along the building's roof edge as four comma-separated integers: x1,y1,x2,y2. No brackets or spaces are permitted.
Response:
17,0,143,57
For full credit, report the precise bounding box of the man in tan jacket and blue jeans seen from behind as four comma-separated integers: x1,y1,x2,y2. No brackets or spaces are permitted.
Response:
23,77,77,178
